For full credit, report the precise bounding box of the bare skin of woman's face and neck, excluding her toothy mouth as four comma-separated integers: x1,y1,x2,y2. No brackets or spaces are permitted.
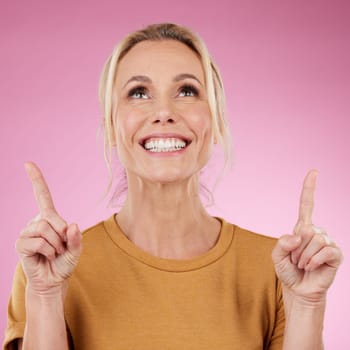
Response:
116,41,220,259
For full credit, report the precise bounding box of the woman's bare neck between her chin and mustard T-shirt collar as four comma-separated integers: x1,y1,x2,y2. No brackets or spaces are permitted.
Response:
117,178,220,259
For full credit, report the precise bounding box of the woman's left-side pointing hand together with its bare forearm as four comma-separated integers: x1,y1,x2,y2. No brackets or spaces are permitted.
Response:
16,163,82,350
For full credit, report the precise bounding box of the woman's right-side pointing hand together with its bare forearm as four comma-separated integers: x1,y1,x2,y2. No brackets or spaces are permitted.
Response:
272,170,343,350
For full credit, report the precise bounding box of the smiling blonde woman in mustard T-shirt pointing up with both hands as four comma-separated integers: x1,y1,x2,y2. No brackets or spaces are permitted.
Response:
4,24,342,350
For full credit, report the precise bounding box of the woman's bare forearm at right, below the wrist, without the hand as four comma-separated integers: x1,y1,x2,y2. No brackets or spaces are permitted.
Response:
283,290,325,350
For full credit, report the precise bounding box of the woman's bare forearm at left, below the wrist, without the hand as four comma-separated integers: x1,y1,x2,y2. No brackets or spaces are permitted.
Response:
23,288,68,350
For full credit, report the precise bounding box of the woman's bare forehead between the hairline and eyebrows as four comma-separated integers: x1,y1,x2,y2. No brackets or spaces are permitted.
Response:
116,40,204,85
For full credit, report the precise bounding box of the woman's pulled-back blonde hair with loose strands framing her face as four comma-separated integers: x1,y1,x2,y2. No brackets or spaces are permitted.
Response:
99,23,232,202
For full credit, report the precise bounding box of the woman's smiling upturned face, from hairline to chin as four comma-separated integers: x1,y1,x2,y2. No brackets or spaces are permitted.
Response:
116,40,213,183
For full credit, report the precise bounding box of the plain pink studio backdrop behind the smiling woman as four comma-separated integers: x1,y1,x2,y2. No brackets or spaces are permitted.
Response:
0,0,350,350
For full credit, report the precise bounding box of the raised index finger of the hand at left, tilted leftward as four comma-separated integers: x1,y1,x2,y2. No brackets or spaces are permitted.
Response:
24,162,56,213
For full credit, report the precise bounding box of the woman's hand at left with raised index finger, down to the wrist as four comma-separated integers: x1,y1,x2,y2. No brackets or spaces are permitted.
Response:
16,162,82,295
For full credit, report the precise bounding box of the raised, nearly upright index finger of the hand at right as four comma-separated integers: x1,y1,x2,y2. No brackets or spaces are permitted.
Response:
298,170,318,224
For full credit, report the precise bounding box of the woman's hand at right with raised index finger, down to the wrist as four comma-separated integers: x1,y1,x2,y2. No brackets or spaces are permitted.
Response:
272,170,343,303
